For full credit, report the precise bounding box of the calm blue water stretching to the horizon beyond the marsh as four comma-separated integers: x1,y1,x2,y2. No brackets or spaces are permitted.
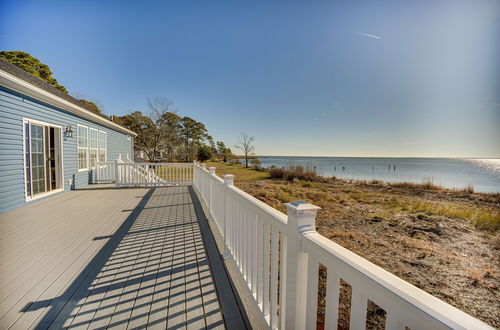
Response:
252,156,500,192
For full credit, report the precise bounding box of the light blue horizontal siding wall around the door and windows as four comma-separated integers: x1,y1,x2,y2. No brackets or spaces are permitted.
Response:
0,86,132,213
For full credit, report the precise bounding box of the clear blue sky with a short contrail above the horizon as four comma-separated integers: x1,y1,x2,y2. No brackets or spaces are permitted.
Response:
0,0,500,157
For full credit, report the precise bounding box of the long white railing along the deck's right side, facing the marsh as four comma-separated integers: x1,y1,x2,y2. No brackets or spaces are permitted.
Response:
194,164,490,329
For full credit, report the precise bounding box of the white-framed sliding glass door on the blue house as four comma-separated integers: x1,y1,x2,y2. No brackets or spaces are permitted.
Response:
23,119,63,200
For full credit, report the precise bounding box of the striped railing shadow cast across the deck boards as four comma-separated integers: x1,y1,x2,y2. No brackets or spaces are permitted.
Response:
22,188,228,329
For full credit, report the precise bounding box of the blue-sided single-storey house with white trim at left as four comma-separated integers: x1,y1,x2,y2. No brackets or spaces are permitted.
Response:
0,59,136,213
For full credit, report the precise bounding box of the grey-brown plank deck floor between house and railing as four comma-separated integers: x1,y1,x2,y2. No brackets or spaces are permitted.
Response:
0,186,248,329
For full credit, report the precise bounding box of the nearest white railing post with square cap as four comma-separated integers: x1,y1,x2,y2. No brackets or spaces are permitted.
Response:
280,201,321,330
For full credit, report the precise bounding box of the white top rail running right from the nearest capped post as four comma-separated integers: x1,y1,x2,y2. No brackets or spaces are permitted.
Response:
303,232,492,329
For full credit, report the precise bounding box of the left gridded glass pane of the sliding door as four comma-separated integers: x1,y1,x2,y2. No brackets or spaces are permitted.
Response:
31,124,45,195
